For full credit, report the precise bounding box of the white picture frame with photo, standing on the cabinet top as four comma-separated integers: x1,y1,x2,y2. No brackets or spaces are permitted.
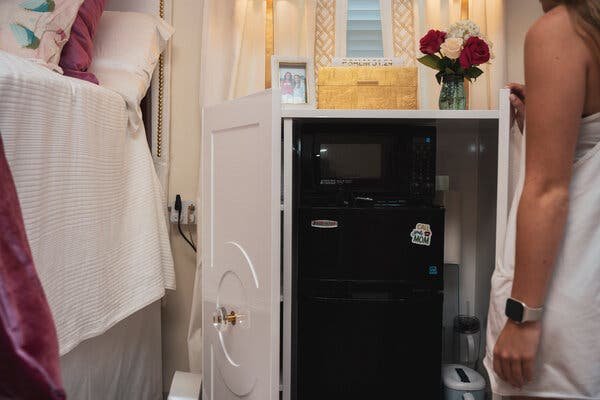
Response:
271,56,317,109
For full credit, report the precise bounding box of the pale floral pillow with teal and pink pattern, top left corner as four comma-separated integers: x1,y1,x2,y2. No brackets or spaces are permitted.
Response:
0,0,83,72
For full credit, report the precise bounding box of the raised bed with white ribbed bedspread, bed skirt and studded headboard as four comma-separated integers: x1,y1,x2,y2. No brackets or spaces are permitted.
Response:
0,0,175,400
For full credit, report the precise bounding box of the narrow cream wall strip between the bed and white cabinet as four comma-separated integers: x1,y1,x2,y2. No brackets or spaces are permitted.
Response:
162,0,203,391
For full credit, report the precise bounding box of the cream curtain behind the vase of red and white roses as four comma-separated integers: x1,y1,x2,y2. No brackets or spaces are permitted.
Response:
414,0,507,109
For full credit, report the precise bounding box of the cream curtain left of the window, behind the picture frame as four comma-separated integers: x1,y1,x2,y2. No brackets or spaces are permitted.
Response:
200,0,315,106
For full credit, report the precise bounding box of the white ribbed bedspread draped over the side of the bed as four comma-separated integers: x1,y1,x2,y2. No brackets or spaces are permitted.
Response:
0,51,175,355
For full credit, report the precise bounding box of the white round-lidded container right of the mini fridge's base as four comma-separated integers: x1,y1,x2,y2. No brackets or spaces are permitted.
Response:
442,364,485,400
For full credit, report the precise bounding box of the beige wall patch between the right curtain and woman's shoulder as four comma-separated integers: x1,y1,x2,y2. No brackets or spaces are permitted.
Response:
505,0,543,82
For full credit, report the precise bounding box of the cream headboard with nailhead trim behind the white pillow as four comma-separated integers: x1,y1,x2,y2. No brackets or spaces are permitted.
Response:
106,0,173,189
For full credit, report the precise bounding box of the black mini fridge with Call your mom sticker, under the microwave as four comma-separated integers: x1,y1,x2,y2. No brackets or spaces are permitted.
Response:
292,205,444,400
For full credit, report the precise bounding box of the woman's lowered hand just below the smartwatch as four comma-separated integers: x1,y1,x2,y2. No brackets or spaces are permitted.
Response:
494,320,542,388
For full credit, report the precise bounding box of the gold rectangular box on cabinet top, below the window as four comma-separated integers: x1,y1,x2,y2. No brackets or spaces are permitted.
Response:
317,67,418,110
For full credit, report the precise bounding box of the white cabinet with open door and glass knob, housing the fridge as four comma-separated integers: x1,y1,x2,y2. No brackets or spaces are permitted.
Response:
201,90,510,400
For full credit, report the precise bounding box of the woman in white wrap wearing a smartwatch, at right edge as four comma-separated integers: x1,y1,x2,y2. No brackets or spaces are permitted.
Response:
485,0,600,399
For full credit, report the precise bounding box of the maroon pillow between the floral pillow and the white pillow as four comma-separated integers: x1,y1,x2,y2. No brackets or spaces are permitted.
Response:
59,0,106,84
